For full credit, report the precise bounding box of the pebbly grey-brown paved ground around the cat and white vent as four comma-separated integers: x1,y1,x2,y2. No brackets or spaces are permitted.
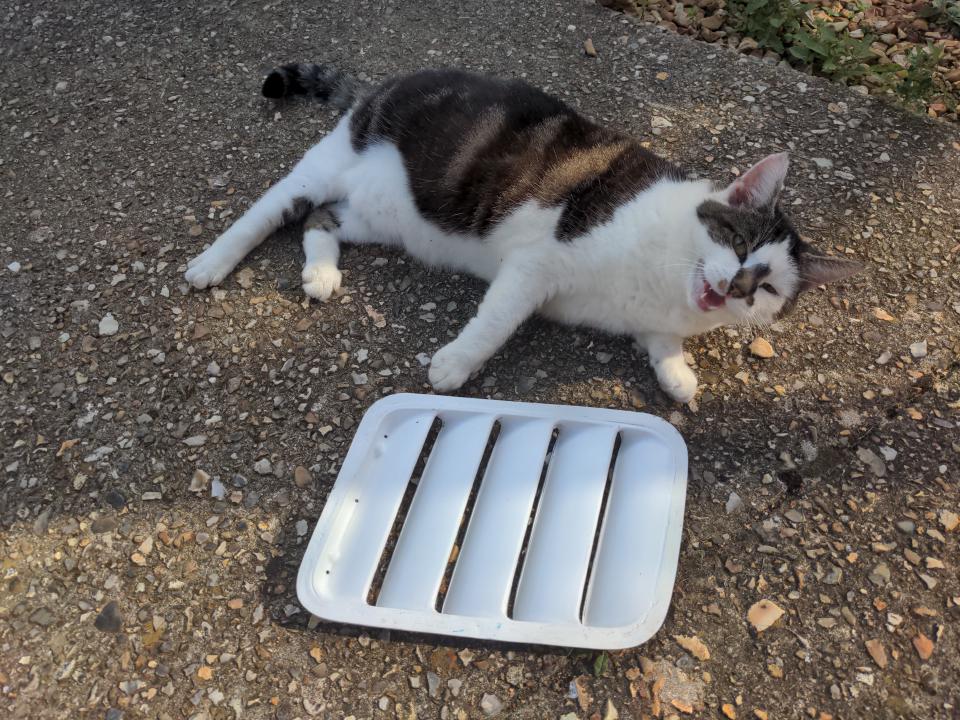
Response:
0,0,960,720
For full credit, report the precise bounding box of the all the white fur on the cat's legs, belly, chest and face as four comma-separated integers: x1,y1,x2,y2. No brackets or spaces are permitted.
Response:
186,115,798,402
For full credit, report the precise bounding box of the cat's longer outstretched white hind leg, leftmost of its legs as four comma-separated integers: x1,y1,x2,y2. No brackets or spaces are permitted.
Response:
184,117,357,289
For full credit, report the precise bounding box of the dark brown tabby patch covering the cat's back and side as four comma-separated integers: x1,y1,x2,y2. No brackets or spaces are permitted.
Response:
350,70,681,239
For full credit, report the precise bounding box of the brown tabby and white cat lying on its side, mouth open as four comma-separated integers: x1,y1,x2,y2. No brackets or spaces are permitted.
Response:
185,64,863,403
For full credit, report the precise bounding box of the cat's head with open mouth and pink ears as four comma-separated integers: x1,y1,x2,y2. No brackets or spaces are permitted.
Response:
690,153,863,324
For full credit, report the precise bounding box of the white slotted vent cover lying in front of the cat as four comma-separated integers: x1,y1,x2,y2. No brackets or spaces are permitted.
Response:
297,395,687,649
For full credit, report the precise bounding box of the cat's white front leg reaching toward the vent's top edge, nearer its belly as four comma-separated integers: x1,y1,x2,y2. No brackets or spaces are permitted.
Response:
429,262,550,392
